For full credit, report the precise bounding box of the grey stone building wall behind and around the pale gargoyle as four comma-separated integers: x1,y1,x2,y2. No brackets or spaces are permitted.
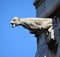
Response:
33,0,60,57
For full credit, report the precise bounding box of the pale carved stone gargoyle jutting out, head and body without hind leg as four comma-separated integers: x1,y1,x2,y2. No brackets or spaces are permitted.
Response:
10,17,52,34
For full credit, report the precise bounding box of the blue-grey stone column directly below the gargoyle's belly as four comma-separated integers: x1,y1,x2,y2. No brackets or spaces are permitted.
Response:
35,32,48,57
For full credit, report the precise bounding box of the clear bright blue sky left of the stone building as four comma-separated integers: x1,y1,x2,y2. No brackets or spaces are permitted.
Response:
0,0,36,57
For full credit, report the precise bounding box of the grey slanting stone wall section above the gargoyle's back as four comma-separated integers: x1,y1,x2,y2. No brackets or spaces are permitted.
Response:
35,0,60,17
